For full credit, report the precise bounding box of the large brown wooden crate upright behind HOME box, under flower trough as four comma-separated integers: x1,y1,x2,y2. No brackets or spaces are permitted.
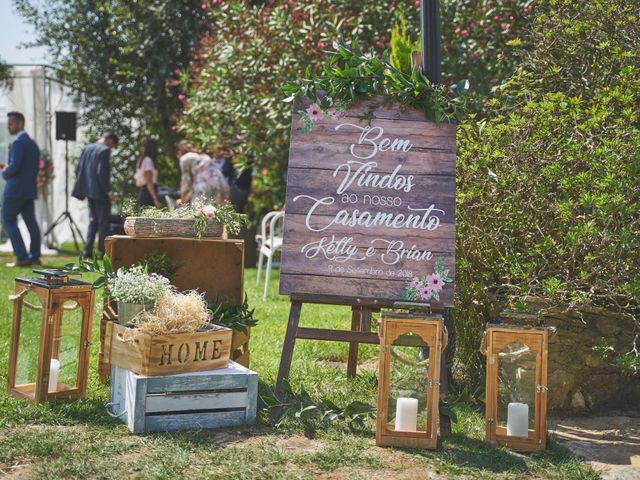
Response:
98,235,248,381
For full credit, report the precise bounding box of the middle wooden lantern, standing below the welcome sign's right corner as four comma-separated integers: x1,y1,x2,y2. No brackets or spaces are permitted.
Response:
376,312,447,449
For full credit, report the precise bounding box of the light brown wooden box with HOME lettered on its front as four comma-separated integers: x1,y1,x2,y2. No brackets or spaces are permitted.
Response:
105,322,232,376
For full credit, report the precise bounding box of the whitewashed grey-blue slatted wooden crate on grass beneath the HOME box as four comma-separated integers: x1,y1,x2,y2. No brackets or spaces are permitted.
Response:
109,362,258,433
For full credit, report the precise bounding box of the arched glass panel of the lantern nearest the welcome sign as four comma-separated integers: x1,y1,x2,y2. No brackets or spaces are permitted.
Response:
387,332,429,432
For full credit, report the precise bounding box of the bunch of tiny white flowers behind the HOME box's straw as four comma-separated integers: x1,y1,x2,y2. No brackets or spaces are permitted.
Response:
107,265,171,305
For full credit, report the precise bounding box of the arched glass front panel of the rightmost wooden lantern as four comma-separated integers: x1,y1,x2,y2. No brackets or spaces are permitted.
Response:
496,342,536,438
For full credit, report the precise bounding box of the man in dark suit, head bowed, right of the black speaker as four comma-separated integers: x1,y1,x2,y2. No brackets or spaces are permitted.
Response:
71,132,118,257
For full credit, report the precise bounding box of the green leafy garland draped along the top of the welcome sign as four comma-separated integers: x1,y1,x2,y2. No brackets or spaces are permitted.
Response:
283,42,471,124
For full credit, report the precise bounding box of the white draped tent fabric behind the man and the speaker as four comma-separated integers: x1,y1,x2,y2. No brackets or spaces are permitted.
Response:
0,65,89,250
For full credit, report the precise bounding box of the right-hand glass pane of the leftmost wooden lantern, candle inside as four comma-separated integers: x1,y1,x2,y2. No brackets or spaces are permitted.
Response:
49,300,84,392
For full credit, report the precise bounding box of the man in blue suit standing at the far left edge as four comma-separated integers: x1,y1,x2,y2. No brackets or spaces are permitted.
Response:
0,112,40,267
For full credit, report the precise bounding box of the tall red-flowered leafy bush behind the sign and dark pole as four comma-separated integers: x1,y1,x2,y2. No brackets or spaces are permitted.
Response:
180,0,530,216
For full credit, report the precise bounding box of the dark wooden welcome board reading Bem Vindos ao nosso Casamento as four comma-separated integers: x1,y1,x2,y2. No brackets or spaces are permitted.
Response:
280,98,456,308
